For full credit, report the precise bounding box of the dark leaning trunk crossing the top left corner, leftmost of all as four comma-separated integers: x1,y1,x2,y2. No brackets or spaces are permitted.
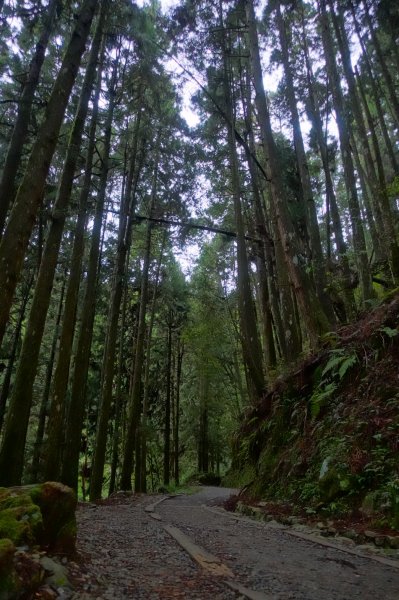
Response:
0,0,63,238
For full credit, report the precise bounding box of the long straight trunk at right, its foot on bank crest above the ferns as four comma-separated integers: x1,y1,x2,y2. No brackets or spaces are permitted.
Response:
319,0,374,301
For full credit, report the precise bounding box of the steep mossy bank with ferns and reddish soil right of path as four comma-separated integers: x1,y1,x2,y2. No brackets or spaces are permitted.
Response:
223,294,399,528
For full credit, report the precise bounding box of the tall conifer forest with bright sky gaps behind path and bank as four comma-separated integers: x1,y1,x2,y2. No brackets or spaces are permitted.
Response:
0,0,399,499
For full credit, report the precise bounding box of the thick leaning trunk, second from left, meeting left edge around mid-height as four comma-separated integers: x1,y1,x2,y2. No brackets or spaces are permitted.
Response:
0,0,98,350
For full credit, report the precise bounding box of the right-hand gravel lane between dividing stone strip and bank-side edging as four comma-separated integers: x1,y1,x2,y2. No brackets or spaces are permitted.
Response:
157,488,399,600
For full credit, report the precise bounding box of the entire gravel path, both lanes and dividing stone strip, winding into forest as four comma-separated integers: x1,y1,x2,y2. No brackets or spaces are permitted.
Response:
72,488,399,600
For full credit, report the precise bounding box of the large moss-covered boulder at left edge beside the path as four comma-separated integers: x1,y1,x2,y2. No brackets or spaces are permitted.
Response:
0,482,76,553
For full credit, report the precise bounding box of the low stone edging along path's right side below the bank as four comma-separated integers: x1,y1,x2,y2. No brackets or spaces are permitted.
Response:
202,504,399,569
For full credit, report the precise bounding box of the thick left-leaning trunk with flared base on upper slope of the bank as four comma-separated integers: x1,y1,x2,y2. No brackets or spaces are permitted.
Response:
245,0,330,346
